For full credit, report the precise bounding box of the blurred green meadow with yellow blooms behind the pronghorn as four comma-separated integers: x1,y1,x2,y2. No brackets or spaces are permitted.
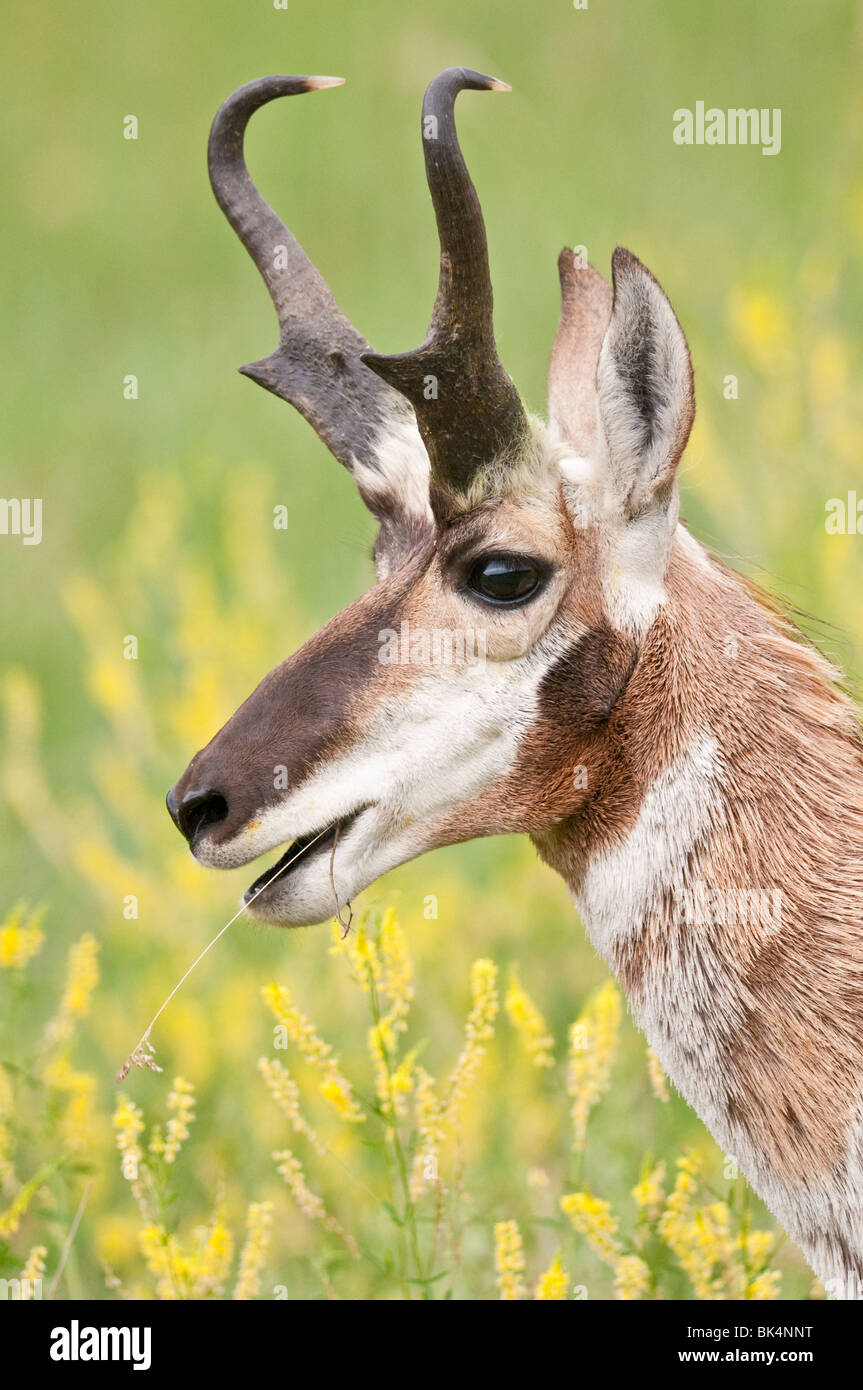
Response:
0,0,863,1297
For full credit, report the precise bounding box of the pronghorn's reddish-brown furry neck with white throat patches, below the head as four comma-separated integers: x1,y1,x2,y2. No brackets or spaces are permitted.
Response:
530,538,863,1295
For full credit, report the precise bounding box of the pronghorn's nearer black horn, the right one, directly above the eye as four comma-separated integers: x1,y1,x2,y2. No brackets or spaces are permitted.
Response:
363,68,528,492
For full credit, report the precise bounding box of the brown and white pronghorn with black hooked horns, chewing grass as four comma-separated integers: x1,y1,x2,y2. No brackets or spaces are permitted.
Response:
168,68,863,1297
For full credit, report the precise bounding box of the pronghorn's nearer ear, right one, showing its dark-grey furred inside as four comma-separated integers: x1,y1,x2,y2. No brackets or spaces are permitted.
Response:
596,246,695,517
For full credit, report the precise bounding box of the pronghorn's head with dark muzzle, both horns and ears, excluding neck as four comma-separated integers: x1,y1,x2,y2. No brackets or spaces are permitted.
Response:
168,68,693,926
